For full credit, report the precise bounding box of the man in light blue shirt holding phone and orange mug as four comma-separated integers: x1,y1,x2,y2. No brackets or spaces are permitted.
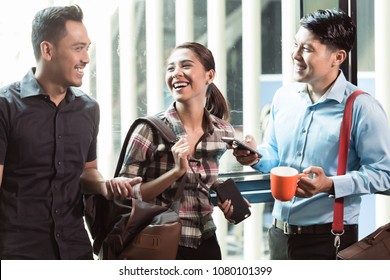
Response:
230,10,390,259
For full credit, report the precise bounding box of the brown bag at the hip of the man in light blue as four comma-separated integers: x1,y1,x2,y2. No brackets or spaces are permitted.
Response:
337,223,390,260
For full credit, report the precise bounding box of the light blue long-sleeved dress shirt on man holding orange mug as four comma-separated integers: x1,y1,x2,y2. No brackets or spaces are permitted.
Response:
253,72,390,226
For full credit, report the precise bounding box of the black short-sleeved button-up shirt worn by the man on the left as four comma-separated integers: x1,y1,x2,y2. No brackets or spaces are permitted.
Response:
0,69,99,259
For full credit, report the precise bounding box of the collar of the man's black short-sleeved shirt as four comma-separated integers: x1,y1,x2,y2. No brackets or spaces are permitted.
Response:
20,67,85,100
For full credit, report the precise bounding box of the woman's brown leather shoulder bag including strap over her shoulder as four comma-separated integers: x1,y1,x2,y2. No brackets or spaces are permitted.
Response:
84,116,186,260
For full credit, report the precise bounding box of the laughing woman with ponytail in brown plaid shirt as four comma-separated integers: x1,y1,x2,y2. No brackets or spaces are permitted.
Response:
121,42,234,259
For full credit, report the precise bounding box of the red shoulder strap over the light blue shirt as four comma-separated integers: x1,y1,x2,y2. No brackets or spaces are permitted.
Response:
332,90,365,234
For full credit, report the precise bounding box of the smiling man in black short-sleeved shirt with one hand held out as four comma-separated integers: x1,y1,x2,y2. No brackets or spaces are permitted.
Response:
0,6,140,259
